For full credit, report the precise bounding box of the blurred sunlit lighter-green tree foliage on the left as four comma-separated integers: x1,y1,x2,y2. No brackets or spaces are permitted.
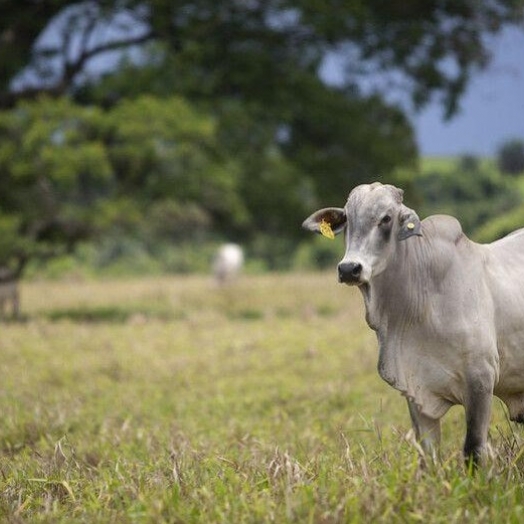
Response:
0,97,260,276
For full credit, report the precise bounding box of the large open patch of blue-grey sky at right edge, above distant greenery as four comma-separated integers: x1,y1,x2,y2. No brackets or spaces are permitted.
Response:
412,29,524,156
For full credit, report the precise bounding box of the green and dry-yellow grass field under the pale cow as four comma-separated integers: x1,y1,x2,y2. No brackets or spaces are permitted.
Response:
0,272,524,524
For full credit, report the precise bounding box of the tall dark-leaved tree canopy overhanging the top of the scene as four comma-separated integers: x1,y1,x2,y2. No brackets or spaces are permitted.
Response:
4,0,523,201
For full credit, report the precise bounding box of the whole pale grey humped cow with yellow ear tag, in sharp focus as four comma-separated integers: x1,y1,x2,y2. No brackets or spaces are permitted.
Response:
303,182,524,467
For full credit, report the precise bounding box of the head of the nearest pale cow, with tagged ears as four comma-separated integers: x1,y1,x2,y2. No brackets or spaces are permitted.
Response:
302,182,421,285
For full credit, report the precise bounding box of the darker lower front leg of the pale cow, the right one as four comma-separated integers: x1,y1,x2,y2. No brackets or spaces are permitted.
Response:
464,373,495,466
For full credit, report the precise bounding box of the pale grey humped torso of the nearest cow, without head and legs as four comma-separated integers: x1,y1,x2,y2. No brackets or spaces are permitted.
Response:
372,216,524,419
